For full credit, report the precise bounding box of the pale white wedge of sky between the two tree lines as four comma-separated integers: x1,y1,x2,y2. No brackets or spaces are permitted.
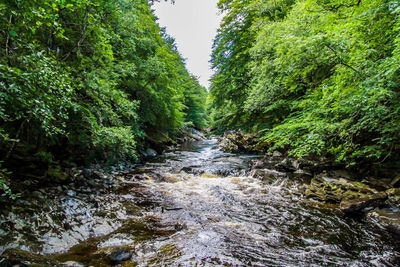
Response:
153,0,221,88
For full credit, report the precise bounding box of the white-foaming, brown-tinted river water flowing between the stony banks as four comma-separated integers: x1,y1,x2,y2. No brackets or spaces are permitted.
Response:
0,139,400,266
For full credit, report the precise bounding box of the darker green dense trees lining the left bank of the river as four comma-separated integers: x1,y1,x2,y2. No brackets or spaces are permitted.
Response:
0,0,206,189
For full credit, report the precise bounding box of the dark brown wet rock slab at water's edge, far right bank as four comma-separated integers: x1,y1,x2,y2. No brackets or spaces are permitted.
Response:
340,192,388,214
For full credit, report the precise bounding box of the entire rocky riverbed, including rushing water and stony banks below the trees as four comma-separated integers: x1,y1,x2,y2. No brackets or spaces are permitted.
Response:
0,139,400,266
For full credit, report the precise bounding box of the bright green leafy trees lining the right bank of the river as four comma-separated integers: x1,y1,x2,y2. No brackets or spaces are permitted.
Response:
210,0,400,164
